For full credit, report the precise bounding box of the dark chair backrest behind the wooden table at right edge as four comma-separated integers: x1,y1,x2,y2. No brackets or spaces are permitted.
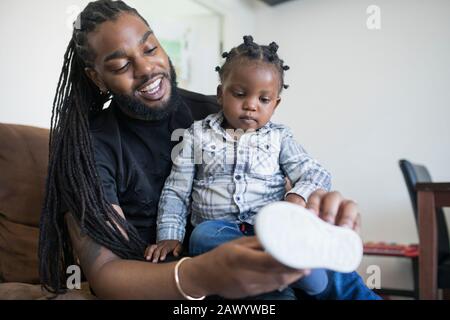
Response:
399,159,450,257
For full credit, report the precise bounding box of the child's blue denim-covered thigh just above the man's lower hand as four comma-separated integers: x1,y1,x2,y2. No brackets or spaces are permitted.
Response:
189,220,243,256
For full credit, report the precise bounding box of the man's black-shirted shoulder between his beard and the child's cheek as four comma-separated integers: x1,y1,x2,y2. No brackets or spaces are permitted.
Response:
177,88,220,120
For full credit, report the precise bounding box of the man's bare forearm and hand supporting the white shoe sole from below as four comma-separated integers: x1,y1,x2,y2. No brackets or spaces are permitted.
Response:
66,213,303,299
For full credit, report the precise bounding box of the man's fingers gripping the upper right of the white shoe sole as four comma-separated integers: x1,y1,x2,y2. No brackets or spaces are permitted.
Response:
306,189,361,233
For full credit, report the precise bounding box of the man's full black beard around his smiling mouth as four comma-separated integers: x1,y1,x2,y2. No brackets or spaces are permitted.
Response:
113,59,179,121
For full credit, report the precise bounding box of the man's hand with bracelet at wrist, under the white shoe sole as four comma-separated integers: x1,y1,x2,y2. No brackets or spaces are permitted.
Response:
186,237,310,299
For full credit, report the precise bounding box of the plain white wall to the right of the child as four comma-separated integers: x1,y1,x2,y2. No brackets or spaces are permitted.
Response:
255,0,450,288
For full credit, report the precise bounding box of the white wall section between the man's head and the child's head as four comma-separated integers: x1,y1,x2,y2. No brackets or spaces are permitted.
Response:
133,0,221,94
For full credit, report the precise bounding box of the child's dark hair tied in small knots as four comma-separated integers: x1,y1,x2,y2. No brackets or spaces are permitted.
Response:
216,36,289,93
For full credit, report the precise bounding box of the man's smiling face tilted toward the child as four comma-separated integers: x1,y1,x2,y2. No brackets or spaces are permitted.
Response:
86,13,174,117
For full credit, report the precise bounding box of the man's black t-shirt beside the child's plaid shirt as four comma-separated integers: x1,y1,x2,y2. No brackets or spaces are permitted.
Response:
90,89,219,243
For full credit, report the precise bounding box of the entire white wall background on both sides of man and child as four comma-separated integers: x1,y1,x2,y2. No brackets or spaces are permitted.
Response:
0,0,450,294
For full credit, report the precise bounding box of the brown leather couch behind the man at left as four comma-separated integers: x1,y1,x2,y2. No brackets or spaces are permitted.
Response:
0,123,94,300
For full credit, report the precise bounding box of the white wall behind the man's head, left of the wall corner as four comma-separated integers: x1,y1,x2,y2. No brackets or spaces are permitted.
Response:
0,0,221,128
